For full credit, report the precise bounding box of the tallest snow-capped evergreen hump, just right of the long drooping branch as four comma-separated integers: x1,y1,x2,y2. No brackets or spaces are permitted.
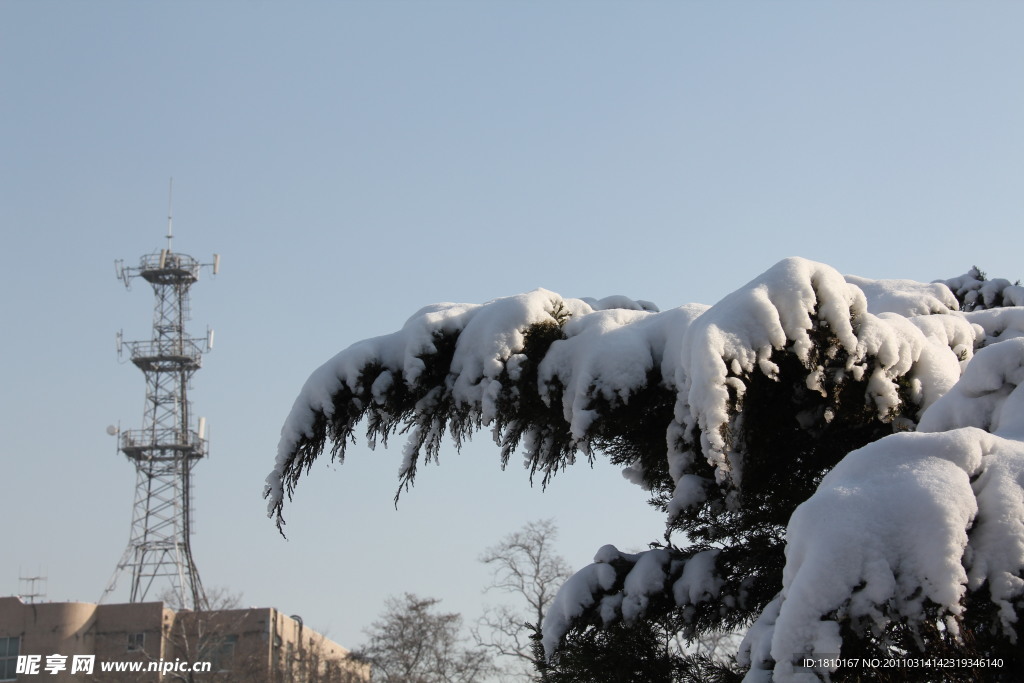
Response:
668,258,975,513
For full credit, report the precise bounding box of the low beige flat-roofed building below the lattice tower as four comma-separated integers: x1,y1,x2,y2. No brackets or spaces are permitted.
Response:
0,597,370,683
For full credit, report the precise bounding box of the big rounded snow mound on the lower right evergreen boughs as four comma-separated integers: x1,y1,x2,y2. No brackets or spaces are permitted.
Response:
740,338,1024,679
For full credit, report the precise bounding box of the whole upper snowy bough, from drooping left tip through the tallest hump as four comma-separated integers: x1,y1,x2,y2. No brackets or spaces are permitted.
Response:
266,258,974,521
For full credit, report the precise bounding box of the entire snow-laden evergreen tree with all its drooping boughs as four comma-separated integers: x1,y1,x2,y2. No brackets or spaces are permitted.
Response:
266,258,1024,680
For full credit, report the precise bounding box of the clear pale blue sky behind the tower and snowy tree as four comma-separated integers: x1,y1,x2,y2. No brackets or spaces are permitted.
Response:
0,1,1024,659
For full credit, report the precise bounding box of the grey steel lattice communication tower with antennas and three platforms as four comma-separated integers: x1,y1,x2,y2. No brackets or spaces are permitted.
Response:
100,200,220,609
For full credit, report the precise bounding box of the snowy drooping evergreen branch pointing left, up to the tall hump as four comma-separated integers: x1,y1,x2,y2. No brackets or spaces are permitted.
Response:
265,290,671,524
